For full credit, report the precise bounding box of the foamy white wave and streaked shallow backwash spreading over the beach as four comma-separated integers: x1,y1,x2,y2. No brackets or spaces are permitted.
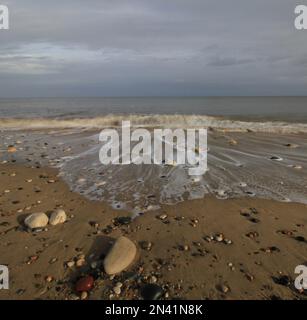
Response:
0,119,307,212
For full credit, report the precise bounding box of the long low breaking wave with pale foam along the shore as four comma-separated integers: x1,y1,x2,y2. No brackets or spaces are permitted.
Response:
0,114,307,133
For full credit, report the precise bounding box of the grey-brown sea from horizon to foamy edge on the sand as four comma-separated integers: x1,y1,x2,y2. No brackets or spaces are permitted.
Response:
0,97,307,214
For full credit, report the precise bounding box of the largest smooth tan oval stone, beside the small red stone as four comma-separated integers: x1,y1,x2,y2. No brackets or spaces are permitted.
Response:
103,236,137,275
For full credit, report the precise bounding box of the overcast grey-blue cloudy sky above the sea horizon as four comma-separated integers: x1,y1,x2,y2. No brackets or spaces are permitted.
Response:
0,0,307,97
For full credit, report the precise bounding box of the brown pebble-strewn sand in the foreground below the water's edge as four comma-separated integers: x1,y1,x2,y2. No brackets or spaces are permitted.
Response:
0,163,307,299
